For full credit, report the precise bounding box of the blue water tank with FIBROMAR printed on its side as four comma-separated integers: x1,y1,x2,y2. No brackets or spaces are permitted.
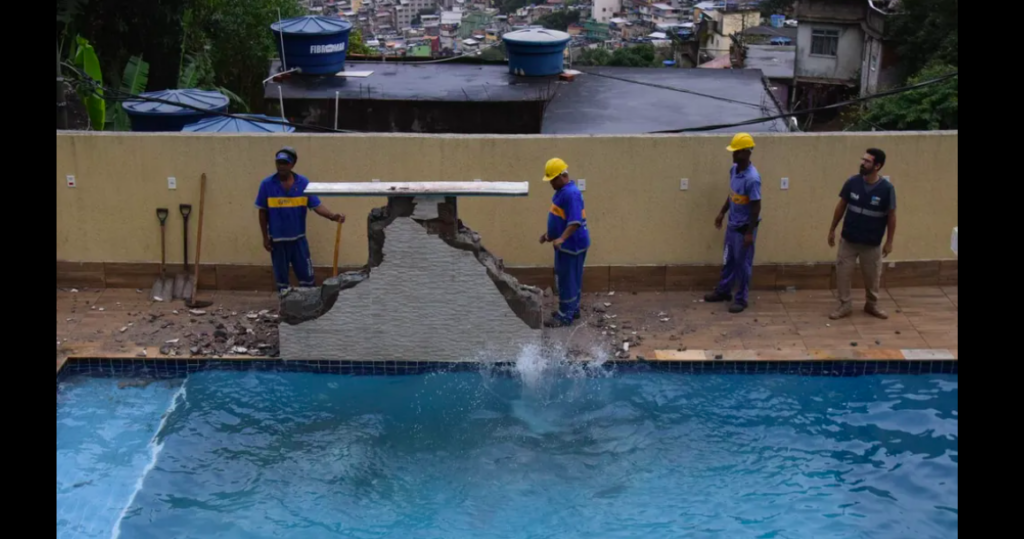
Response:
270,15,352,75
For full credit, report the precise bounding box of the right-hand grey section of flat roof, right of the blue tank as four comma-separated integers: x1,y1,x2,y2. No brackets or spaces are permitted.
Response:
542,68,785,134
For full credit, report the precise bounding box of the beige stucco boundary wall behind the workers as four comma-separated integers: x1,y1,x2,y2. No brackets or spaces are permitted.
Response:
56,132,959,266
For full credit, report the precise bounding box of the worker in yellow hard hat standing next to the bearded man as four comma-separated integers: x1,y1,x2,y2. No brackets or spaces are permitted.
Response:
705,133,761,315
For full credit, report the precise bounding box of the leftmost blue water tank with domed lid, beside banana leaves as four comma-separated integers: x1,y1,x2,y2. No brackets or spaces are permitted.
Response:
121,90,228,131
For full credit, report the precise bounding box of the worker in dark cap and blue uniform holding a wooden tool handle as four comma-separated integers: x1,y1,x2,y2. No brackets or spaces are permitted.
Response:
256,148,345,292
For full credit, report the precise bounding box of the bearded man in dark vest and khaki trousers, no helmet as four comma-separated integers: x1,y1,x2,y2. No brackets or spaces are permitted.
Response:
828,149,896,320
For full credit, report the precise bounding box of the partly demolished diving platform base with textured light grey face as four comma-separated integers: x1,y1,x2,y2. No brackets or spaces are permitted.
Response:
272,197,543,361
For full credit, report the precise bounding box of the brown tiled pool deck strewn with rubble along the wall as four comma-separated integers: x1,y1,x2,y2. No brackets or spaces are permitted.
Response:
56,287,959,372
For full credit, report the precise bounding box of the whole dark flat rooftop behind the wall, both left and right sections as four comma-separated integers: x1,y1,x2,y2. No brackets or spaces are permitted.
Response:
265,60,785,134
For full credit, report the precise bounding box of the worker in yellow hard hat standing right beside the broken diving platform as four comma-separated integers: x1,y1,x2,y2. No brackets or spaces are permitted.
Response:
541,158,590,327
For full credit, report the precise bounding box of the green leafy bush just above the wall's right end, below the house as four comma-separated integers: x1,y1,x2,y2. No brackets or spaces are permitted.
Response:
858,63,959,131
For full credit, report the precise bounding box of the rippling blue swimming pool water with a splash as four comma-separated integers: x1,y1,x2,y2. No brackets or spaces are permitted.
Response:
56,372,959,539
